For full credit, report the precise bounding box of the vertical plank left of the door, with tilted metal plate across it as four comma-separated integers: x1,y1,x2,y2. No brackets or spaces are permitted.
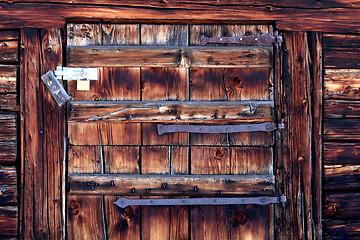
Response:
39,29,65,239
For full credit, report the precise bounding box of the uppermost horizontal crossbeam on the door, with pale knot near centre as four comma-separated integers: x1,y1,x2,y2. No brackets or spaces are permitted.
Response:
67,46,272,68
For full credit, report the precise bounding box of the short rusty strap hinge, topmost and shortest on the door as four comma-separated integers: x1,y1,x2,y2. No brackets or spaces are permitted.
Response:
200,33,283,46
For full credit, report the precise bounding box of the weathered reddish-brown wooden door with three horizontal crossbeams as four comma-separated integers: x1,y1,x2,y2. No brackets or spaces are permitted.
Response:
67,24,278,240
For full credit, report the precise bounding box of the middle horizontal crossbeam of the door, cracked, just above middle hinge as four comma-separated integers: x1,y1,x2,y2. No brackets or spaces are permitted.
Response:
69,101,273,122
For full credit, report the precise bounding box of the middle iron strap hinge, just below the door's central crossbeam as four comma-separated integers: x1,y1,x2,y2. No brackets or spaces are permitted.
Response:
157,121,285,135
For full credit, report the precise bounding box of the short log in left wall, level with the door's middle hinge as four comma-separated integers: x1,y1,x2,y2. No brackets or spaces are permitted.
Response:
0,114,16,142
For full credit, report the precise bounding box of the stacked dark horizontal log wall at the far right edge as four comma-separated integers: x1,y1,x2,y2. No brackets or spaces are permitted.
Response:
323,34,360,239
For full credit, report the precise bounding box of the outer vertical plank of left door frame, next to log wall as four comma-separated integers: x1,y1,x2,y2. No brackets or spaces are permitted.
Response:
20,29,45,239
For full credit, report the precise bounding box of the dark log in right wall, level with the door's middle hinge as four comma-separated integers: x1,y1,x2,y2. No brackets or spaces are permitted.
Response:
324,119,360,141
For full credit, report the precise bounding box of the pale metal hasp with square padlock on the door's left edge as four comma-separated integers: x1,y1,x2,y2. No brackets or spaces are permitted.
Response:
55,66,98,91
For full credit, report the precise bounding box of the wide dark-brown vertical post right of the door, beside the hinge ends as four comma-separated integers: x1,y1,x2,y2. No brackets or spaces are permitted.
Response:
275,32,313,239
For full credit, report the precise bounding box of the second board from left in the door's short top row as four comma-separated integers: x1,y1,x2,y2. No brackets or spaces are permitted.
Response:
101,24,140,46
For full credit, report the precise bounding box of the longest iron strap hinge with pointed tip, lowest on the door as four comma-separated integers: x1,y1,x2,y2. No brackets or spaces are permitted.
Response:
113,195,287,208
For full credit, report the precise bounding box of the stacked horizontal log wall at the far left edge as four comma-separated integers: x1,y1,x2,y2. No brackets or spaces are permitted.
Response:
0,31,19,238
